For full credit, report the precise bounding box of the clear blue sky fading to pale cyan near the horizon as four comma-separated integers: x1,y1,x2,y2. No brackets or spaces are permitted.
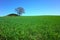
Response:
0,0,60,16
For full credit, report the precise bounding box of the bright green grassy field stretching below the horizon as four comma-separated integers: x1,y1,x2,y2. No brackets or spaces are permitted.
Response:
0,16,60,40
